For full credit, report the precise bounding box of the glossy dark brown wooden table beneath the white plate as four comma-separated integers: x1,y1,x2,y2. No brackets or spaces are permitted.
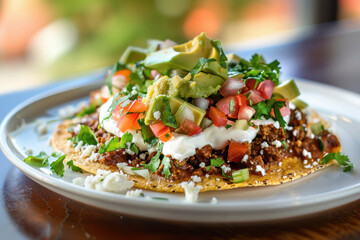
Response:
0,21,360,239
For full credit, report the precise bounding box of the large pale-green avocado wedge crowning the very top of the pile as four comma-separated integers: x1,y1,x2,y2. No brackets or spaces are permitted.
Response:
144,33,227,79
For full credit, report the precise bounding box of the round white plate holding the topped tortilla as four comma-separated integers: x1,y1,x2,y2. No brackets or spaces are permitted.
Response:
0,80,360,222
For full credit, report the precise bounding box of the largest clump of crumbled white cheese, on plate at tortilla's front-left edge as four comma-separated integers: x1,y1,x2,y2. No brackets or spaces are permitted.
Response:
84,169,134,193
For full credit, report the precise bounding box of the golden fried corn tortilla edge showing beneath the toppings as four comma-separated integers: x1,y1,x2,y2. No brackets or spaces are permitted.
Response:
51,120,340,192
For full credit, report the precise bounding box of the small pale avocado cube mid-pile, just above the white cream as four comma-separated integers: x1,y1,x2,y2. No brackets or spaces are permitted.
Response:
175,102,206,126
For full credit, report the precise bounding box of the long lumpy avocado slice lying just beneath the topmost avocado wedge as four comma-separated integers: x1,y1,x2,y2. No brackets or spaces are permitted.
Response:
143,72,225,105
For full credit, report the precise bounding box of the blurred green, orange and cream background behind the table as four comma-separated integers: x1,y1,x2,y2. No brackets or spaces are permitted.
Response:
0,0,360,93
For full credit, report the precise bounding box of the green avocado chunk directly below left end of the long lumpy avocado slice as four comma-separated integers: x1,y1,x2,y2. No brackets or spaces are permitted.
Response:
145,95,178,128
